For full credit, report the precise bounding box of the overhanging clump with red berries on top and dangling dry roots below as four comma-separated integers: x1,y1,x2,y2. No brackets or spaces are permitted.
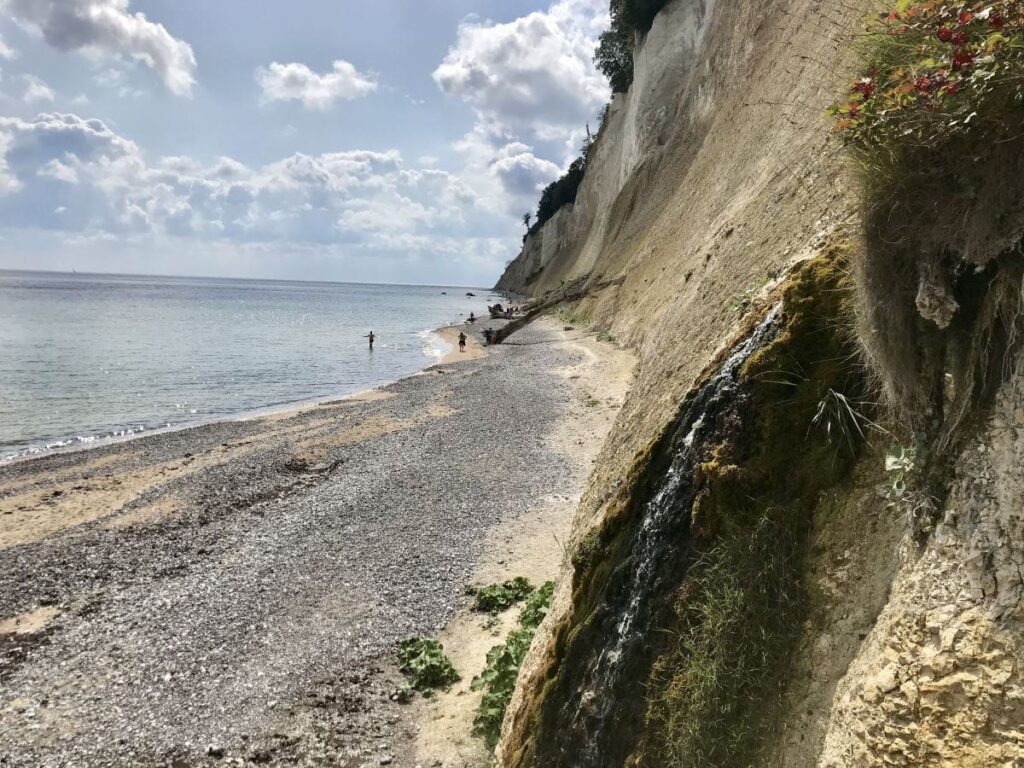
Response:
831,0,1024,434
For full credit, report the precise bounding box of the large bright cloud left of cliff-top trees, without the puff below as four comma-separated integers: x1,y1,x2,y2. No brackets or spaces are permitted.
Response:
433,0,609,140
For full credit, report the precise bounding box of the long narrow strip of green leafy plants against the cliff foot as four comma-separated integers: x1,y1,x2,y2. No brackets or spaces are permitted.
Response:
471,582,555,748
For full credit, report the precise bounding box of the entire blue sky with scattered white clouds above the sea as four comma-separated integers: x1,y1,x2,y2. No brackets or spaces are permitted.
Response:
0,0,610,285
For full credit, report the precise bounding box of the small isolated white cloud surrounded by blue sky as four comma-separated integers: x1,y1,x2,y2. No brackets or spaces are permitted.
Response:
256,60,377,110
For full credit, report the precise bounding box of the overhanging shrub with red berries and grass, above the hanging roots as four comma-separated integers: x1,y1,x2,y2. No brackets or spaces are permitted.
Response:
830,0,1024,263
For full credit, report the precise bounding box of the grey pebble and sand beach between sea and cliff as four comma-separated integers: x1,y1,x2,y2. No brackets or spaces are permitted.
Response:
0,321,631,768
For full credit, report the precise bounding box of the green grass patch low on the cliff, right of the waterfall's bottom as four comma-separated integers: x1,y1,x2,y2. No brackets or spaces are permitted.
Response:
646,518,803,768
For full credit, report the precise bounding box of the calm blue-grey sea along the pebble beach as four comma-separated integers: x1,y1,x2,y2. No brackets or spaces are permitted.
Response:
0,270,488,459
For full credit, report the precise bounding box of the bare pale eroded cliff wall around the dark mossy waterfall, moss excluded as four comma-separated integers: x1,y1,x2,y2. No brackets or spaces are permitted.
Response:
498,0,1024,767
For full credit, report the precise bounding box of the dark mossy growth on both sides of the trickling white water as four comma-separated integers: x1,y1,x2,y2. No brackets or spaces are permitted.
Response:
512,246,866,768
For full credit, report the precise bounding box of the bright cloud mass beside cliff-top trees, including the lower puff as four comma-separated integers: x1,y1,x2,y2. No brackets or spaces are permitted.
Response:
433,0,610,220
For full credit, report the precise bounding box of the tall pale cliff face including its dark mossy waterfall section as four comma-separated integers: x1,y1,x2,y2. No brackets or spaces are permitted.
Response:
498,0,1024,768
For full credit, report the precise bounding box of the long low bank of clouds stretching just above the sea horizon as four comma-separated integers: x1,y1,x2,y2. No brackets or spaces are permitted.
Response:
0,114,509,262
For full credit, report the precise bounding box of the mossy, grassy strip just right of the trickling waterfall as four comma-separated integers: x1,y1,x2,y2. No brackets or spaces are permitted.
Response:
635,246,868,768
